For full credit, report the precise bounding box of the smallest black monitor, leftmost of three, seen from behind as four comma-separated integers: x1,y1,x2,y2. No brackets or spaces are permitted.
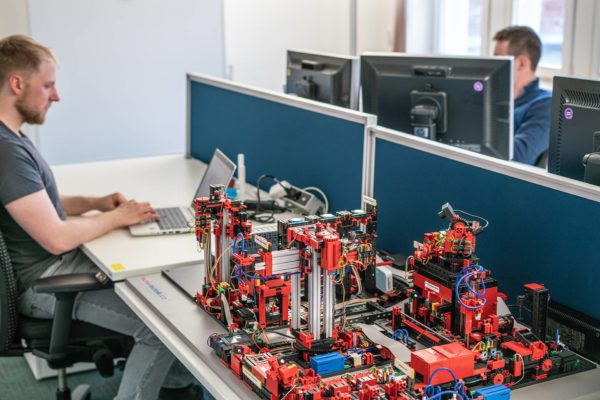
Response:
285,50,360,110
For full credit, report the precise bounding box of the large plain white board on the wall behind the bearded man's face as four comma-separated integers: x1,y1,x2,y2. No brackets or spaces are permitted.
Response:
25,0,224,164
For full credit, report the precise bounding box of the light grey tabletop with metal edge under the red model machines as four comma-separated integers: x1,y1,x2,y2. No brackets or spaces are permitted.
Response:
115,274,600,400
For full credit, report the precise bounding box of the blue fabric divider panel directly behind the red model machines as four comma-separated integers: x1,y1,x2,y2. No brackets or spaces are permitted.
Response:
374,139,600,318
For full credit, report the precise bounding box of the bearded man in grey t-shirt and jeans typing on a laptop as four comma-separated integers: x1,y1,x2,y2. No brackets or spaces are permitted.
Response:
0,35,200,400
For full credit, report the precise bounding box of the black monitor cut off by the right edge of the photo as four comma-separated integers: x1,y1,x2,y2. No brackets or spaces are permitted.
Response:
548,76,600,184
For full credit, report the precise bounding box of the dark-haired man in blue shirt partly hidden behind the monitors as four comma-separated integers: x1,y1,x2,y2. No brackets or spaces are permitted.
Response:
494,26,552,165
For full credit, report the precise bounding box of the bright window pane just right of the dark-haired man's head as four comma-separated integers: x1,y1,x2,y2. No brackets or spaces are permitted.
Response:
513,0,567,69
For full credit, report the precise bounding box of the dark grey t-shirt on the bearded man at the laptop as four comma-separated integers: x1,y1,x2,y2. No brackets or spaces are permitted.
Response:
0,121,67,292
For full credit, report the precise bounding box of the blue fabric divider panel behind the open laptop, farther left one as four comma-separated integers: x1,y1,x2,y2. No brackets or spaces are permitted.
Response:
190,81,365,212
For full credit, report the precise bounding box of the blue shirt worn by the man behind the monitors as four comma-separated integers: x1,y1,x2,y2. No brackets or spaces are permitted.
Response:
513,78,552,165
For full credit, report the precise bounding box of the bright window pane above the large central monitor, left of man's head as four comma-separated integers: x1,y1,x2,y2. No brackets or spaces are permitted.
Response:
434,0,484,55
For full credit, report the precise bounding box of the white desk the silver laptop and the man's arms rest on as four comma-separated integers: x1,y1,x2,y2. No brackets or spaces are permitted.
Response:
53,155,206,281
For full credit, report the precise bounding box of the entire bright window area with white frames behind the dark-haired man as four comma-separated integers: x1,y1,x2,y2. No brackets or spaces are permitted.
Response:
405,0,600,80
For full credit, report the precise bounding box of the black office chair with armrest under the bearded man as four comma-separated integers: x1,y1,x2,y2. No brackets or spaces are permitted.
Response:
0,232,133,400
